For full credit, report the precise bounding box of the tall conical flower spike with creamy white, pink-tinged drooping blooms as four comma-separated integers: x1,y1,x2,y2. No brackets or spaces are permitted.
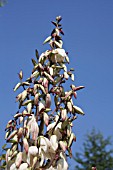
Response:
1,16,84,170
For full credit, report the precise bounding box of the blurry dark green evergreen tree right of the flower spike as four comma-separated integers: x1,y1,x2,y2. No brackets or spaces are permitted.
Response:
74,129,113,170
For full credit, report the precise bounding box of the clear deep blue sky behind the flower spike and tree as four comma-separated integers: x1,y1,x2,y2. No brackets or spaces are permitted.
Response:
0,0,113,169
